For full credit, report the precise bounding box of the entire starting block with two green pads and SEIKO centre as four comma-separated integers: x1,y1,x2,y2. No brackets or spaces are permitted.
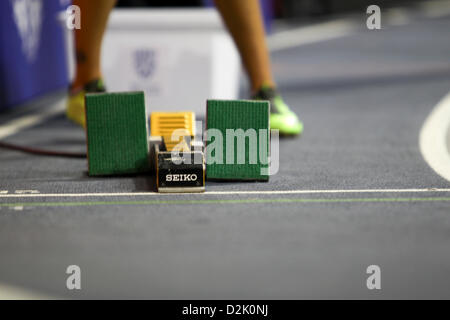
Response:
85,92,270,193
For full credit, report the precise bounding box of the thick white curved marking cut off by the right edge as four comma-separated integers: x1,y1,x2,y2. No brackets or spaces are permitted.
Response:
419,93,450,181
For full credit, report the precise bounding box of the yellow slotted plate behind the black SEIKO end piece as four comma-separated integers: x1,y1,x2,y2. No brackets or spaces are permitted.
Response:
150,112,195,151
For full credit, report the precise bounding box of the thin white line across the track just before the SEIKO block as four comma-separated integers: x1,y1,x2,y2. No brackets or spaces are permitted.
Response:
0,188,450,198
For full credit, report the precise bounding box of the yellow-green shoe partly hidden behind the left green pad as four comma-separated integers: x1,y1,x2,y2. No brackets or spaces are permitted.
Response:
66,79,106,128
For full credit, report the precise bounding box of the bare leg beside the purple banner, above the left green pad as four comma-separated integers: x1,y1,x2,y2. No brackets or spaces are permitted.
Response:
72,0,116,88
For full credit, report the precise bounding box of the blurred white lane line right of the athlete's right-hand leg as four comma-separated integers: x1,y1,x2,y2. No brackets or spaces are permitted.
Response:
267,19,357,52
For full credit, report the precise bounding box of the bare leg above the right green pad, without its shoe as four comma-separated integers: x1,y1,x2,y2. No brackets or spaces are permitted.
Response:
215,0,274,92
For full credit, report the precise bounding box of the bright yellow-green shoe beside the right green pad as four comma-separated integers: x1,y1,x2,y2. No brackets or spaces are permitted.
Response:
252,86,303,135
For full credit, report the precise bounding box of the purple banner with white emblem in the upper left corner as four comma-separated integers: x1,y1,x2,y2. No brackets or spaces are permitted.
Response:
0,0,68,110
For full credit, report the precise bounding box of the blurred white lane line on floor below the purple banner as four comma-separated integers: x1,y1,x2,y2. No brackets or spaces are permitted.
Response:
0,99,64,139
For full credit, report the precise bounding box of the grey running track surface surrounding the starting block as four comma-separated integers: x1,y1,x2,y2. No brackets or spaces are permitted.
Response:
0,18,450,299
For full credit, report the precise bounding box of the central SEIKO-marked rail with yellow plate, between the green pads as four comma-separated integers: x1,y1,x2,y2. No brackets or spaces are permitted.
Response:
150,112,205,193
